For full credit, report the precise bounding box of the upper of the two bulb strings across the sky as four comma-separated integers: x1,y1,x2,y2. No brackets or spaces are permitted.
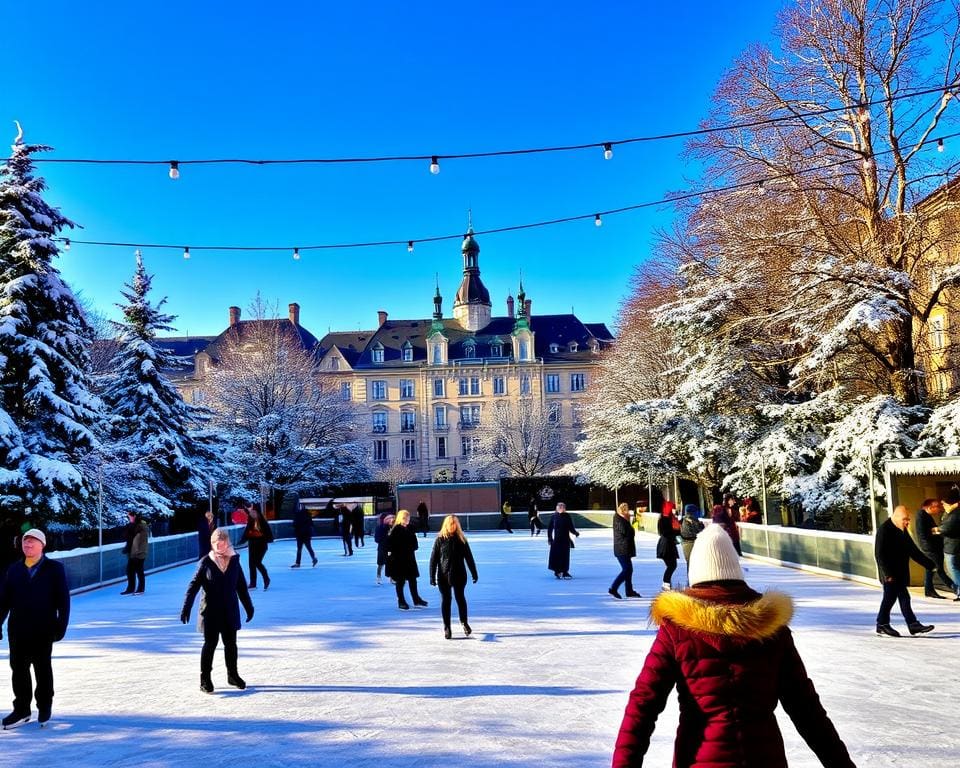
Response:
26,81,960,172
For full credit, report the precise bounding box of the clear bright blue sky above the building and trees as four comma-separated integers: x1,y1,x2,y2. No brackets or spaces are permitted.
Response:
0,0,782,335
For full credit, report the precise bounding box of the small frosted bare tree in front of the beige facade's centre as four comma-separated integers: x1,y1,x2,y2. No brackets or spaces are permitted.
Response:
470,398,574,477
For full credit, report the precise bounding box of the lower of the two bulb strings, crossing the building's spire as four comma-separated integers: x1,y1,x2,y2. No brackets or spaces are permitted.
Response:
57,132,960,260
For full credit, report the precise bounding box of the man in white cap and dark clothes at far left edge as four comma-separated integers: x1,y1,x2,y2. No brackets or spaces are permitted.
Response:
0,528,70,730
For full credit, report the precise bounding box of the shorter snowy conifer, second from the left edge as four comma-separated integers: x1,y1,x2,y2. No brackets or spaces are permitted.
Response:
103,252,222,519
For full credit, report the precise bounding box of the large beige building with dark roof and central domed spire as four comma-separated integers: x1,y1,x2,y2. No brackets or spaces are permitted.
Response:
160,230,613,481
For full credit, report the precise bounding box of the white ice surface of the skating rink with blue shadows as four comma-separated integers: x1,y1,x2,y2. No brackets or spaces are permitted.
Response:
0,529,960,768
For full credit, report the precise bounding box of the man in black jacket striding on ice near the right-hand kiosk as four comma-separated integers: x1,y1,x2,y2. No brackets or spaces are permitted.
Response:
875,505,934,637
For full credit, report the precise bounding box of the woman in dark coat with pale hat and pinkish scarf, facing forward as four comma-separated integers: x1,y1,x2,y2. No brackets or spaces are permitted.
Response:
180,528,253,693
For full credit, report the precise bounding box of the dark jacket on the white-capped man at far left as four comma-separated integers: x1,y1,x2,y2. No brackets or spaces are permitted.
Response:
0,556,70,642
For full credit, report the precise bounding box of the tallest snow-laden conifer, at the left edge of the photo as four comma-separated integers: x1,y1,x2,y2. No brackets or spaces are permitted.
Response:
0,137,102,526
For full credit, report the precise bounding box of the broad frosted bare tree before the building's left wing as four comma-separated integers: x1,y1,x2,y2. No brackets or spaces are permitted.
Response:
204,296,368,498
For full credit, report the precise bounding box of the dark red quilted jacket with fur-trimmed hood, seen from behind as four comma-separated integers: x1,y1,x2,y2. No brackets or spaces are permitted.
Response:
613,582,853,768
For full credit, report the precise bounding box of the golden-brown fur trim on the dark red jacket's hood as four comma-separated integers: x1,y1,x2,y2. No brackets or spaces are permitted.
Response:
650,591,793,640
